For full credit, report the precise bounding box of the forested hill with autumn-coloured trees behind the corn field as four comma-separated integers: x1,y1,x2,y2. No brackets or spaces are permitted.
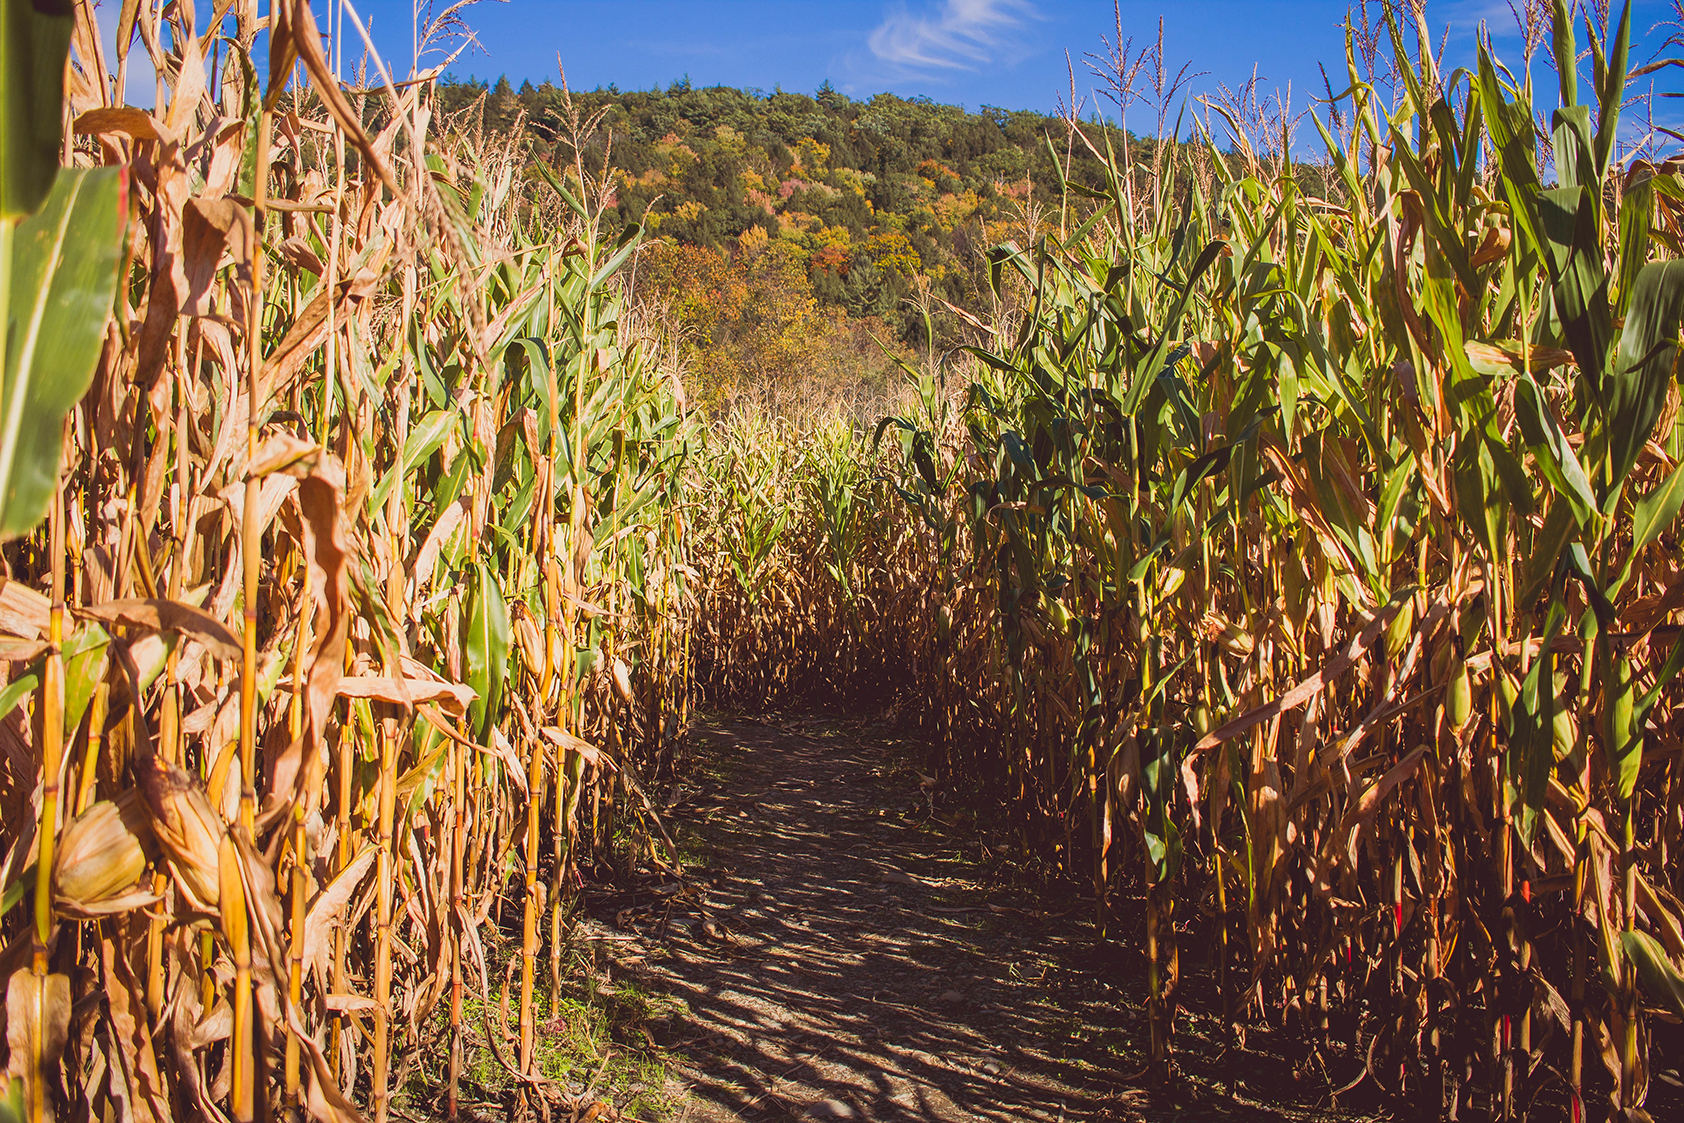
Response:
440,79,1143,404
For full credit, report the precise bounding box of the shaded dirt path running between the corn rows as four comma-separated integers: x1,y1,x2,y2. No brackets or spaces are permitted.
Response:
581,719,1329,1123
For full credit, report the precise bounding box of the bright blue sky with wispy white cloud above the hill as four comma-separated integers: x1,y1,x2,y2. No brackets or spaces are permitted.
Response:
99,0,1684,128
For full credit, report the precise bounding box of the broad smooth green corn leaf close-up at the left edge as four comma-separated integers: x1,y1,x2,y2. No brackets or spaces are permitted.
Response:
0,166,123,539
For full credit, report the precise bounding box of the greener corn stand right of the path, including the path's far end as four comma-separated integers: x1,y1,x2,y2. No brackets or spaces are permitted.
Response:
699,5,1684,1118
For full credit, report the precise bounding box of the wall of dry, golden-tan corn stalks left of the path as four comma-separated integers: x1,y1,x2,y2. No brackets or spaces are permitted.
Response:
0,2,694,1121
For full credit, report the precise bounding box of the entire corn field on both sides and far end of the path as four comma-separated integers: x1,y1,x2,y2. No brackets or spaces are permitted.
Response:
0,0,1684,1123
